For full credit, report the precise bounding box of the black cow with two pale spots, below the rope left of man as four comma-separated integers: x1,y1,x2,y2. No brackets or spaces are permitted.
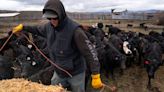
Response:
17,45,48,78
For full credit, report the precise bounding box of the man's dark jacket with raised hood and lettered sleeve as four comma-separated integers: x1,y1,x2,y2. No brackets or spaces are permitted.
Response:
23,0,100,77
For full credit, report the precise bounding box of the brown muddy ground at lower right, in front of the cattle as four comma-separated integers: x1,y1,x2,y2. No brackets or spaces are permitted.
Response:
87,66,164,92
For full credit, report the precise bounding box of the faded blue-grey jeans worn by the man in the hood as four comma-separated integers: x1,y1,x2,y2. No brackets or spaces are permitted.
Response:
51,71,85,92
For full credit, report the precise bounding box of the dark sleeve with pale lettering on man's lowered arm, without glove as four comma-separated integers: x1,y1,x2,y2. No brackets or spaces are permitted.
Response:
74,28,100,74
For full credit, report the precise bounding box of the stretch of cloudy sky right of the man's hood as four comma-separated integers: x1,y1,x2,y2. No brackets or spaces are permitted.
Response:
61,0,164,12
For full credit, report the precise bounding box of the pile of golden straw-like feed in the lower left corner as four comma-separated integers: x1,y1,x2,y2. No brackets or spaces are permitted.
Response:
0,79,66,92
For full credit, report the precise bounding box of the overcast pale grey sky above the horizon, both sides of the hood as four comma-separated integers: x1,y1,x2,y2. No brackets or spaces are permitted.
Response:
0,0,164,12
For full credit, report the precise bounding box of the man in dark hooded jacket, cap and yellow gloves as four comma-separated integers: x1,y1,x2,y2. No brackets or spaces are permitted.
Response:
12,0,103,92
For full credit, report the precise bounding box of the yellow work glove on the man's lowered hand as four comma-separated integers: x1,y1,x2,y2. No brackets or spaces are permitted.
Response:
91,74,103,89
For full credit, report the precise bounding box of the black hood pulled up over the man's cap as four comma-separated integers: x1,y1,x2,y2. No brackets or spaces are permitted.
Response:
43,0,66,23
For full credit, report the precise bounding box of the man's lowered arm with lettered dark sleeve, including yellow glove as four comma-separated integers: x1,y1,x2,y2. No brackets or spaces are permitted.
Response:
74,28,103,88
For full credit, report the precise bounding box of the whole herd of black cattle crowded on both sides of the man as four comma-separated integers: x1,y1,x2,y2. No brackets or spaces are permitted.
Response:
0,23,164,88
